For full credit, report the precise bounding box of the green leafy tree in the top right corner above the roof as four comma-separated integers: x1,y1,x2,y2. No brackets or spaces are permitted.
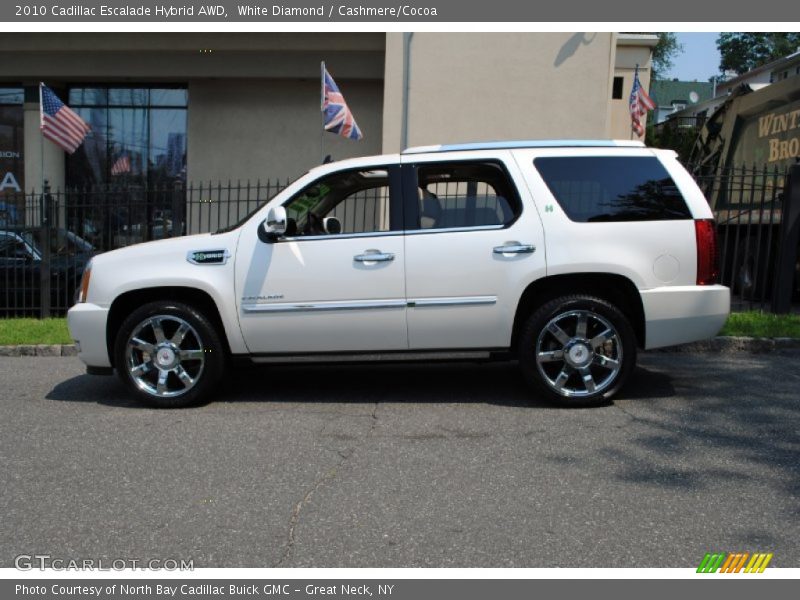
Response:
717,32,800,75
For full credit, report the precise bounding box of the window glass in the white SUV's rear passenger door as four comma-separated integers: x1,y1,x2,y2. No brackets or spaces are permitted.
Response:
417,163,519,229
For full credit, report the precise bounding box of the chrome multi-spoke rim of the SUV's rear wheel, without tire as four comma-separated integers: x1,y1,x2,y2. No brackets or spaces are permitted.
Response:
536,310,622,398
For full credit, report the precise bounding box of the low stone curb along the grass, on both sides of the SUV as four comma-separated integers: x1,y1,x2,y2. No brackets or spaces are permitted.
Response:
0,336,800,357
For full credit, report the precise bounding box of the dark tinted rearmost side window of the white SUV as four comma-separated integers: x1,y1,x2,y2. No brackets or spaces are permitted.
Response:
533,156,692,223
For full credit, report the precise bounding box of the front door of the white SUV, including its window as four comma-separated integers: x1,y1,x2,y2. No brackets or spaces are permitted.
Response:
236,166,408,354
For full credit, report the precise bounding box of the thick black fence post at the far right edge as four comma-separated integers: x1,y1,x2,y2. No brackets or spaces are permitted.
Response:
772,164,800,313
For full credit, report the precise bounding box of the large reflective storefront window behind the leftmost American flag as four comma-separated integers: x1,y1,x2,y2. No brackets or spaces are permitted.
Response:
67,86,187,188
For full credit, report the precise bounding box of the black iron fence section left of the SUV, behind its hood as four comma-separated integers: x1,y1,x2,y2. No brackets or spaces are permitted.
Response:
0,180,289,317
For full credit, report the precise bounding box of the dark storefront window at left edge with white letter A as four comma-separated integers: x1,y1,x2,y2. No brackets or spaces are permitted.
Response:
0,87,25,227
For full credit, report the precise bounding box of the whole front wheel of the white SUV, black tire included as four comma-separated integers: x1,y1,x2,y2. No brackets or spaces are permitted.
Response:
114,301,227,408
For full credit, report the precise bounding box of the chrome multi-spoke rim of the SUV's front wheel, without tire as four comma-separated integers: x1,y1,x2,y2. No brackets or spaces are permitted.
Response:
125,315,205,398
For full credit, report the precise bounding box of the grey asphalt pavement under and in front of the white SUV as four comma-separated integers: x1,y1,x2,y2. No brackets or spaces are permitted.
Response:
0,352,800,567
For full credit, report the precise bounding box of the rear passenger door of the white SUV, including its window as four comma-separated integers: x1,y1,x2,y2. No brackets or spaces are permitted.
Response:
402,152,545,349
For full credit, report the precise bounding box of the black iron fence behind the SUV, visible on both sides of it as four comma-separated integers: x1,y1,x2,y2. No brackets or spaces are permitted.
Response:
0,165,800,317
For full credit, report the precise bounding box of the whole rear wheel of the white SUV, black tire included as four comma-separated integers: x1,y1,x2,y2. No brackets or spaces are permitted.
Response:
517,295,636,407
